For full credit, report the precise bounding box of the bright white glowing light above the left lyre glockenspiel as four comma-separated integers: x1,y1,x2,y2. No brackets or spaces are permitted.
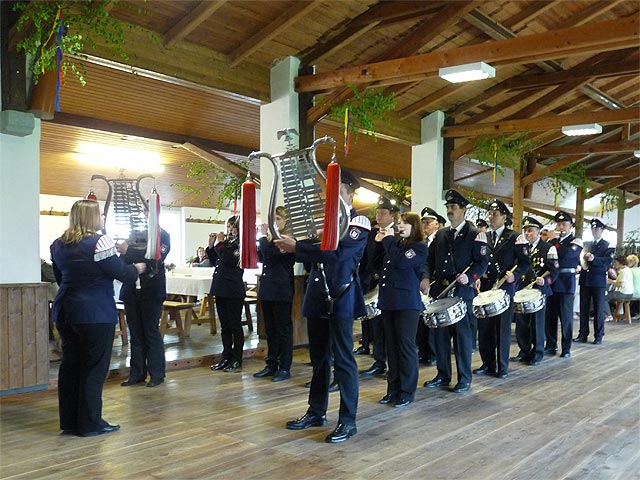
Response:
75,142,164,173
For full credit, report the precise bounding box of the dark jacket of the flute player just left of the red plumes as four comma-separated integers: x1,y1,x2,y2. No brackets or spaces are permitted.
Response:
205,240,247,298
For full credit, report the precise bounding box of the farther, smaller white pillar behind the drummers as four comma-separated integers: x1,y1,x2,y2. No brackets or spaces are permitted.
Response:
411,110,447,218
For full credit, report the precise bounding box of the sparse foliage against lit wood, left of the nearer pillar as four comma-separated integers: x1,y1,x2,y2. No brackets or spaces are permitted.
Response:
171,160,248,210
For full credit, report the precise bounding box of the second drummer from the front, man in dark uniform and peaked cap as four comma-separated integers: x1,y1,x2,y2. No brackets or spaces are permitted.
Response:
473,199,531,379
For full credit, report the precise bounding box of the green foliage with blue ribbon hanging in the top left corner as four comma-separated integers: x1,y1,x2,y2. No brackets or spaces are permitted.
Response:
14,0,134,86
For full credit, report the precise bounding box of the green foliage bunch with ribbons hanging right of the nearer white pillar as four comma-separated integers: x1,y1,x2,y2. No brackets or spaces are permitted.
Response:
329,83,396,141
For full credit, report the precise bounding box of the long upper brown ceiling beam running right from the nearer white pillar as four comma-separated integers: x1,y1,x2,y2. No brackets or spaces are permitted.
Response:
296,16,640,93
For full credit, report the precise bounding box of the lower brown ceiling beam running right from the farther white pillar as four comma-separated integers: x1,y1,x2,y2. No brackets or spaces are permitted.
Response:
442,107,640,138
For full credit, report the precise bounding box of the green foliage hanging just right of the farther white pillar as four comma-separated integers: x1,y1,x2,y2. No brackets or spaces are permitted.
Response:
467,132,538,176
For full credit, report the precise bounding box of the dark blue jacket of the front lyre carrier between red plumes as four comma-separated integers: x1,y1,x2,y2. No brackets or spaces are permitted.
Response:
296,213,369,320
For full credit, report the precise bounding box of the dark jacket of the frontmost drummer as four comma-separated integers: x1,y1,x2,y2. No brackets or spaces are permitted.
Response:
423,221,487,300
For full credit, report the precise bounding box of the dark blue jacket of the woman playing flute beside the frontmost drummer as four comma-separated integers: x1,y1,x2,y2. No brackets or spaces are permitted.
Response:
378,237,427,311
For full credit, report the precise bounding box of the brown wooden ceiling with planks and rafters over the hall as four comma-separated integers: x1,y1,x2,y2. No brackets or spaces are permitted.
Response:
10,0,640,209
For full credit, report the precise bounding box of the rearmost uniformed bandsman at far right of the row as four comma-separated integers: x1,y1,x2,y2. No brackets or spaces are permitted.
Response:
573,218,615,345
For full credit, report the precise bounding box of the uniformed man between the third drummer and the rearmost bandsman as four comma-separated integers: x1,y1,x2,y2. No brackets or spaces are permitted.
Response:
544,211,582,358
